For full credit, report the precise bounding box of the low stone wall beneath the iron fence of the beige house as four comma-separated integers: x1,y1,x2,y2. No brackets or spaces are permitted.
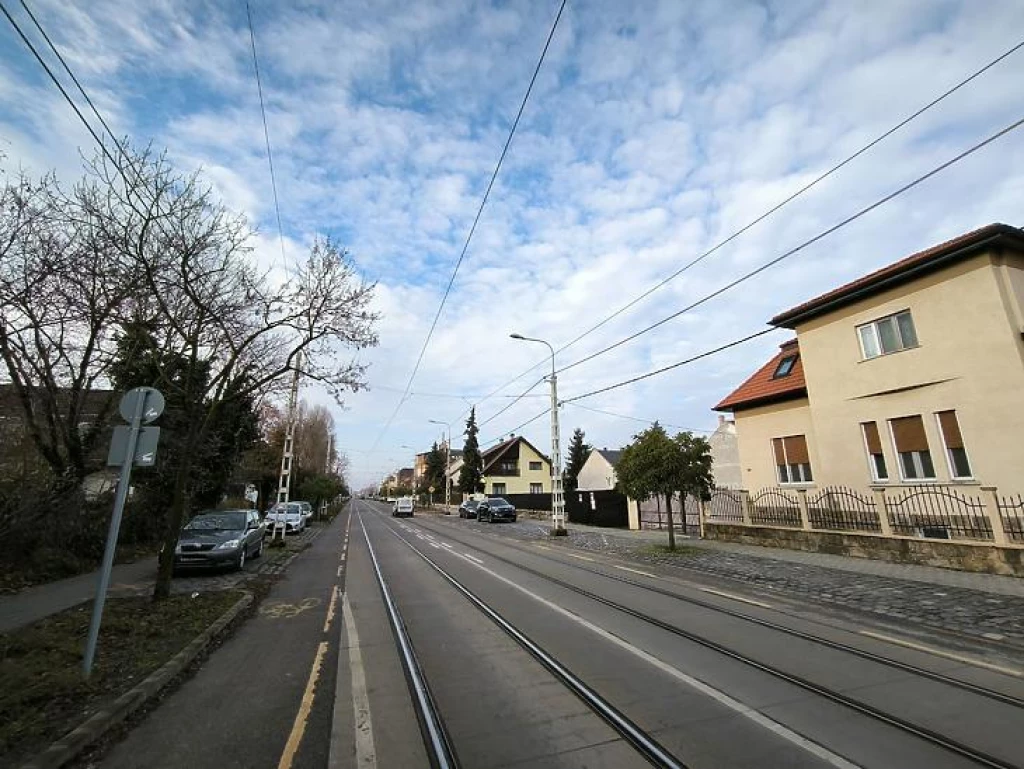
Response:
705,522,1024,576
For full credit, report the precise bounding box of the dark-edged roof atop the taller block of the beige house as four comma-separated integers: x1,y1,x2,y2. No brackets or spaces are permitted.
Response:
770,223,1024,329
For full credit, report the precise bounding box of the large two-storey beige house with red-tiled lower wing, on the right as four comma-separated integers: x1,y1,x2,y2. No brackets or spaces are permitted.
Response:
715,224,1024,490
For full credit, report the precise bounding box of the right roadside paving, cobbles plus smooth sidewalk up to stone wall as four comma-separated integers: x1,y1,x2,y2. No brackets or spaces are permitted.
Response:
467,521,1024,653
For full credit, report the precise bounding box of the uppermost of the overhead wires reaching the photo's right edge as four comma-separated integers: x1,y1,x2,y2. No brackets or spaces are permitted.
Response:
462,40,1024,404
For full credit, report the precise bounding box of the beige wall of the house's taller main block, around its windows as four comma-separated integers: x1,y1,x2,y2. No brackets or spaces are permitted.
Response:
794,254,1024,488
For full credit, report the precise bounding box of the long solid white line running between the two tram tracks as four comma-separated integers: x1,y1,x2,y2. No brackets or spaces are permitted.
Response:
395,533,860,769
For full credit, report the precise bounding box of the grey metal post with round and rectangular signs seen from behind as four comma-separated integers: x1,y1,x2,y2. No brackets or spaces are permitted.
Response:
83,387,164,676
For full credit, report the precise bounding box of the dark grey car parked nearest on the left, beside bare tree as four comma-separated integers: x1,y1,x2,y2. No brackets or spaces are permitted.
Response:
174,510,263,569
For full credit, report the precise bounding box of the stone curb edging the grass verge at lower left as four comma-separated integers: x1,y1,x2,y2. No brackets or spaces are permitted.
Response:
22,593,254,769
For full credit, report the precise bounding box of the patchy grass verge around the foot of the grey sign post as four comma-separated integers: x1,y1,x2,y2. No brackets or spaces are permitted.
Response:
0,591,242,766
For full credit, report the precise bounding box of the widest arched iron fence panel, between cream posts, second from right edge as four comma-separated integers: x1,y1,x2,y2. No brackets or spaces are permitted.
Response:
886,486,992,541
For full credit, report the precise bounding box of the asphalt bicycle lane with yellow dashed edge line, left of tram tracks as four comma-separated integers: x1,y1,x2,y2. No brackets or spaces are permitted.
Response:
98,508,349,769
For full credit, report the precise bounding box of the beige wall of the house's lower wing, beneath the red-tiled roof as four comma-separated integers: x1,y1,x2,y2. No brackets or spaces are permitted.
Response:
735,393,821,489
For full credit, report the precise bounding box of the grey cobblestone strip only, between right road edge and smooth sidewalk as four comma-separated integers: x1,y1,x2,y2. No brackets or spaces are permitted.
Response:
454,520,1024,651
